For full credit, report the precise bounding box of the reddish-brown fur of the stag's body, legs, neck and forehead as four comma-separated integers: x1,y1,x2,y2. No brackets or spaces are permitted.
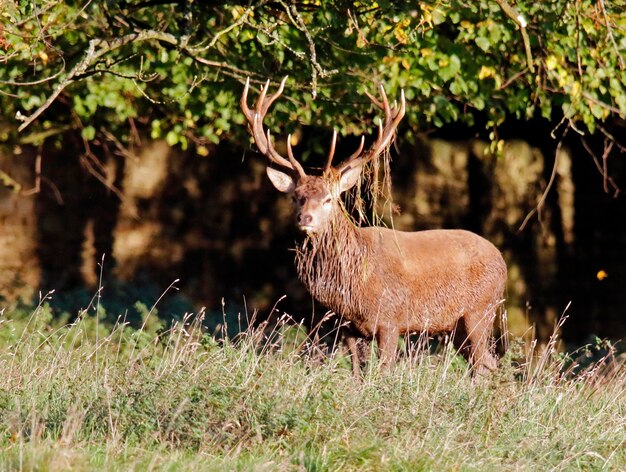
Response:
294,176,507,373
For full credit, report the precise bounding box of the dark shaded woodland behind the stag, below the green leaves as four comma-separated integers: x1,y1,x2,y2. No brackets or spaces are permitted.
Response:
0,116,626,343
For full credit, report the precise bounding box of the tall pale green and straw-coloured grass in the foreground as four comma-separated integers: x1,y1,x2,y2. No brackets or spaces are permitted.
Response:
0,294,626,471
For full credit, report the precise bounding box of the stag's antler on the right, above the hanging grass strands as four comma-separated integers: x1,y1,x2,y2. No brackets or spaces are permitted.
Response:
337,84,406,171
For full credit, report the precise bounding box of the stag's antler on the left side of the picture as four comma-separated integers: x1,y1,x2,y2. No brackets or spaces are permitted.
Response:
241,77,306,177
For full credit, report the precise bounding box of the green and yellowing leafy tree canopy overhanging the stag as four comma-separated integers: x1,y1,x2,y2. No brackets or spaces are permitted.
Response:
0,0,626,154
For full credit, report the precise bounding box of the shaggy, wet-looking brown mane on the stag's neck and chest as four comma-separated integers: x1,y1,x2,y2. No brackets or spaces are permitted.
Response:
296,207,369,319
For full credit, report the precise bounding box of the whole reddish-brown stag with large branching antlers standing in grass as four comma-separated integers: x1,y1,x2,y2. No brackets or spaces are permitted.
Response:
241,77,507,376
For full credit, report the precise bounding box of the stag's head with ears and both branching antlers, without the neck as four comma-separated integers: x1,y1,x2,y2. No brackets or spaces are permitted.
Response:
241,77,405,233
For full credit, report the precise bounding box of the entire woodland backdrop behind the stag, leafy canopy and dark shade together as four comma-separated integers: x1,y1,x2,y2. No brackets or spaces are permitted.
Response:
0,0,626,344
